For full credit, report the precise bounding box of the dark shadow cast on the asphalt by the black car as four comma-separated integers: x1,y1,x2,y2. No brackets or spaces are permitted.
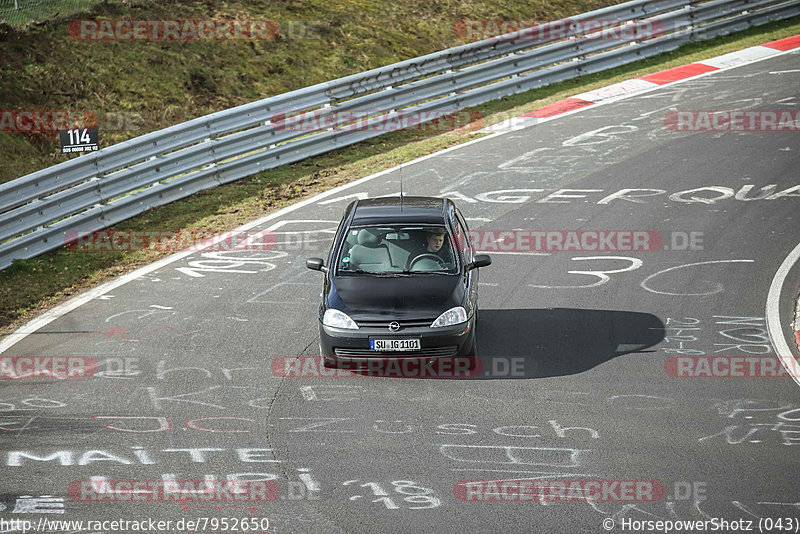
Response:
477,308,665,380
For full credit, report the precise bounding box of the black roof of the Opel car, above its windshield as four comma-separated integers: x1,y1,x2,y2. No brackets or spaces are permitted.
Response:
352,196,447,226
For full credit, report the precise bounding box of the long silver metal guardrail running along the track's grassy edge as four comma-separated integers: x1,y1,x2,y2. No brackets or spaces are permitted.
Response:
0,0,800,269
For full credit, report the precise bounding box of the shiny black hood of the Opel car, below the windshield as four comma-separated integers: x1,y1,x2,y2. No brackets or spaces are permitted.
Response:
328,275,464,321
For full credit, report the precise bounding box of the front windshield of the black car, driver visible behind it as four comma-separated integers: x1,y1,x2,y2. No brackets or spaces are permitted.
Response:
337,225,458,276
